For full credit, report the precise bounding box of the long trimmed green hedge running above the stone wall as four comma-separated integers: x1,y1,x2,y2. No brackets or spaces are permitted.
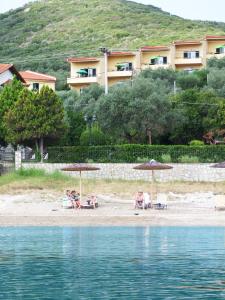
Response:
48,145,225,163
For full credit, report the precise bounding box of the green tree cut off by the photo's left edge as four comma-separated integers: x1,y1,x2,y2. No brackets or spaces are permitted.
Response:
0,78,24,140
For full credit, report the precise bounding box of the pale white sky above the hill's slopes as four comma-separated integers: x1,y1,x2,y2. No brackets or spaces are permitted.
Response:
0,0,225,22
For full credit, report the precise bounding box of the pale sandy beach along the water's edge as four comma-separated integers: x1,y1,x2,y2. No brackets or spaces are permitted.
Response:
0,191,225,226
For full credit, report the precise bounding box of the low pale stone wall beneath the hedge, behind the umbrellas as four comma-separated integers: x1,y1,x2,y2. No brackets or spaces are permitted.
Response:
23,163,225,182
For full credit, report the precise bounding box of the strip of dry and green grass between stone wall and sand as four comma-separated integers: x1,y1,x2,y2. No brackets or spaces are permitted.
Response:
0,169,225,198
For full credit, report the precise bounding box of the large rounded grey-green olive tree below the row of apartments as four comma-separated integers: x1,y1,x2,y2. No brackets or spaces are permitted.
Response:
95,77,175,143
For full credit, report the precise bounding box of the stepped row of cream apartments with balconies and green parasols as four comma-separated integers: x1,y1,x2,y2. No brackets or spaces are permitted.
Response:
67,35,225,92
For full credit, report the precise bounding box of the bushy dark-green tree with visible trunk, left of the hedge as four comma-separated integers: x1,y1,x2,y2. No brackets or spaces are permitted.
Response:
4,86,66,158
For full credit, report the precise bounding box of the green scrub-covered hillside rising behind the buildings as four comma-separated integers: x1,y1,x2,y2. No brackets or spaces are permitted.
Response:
0,0,225,86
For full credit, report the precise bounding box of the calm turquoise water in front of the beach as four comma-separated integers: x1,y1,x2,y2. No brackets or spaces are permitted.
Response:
0,227,225,300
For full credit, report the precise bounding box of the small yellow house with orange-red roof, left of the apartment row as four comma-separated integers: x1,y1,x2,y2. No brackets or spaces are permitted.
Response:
19,71,56,91
